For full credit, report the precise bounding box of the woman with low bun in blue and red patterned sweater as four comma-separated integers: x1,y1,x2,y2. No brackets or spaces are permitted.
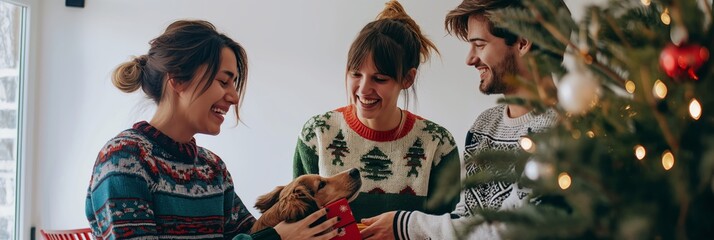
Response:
85,20,337,239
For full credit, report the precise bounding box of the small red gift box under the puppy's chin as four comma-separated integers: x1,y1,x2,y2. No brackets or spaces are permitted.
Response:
325,198,362,240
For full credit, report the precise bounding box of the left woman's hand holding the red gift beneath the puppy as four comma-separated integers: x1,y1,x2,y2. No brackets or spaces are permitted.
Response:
274,208,338,240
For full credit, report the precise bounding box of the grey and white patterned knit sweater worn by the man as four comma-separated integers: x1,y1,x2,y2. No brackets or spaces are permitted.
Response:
394,105,558,239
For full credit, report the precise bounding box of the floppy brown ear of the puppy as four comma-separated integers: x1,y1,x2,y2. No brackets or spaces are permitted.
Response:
278,186,319,222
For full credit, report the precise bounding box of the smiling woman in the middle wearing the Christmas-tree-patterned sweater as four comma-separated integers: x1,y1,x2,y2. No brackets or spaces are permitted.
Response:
293,1,460,221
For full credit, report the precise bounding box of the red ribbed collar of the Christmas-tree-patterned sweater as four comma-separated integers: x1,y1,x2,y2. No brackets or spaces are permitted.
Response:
335,105,422,142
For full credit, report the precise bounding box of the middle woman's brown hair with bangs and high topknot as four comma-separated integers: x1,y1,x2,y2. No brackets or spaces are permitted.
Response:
347,1,439,106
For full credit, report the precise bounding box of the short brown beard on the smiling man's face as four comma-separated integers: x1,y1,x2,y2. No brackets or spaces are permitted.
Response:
479,51,518,95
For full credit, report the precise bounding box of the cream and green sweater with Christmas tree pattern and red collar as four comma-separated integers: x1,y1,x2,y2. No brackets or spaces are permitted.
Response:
293,106,460,221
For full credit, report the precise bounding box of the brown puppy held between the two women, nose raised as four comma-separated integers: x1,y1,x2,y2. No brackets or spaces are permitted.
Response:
251,168,362,232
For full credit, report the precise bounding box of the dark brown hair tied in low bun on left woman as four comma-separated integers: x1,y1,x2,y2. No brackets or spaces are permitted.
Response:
112,20,248,119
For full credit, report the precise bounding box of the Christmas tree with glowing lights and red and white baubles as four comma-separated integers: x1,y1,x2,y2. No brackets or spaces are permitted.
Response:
432,0,714,239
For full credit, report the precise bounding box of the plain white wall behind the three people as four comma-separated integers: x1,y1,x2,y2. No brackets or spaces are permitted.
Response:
28,0,592,232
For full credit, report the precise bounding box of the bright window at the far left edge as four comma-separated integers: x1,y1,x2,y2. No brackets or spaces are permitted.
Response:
0,1,26,239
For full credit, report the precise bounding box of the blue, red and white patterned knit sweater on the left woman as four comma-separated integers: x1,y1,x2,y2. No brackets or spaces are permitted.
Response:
86,122,277,239
